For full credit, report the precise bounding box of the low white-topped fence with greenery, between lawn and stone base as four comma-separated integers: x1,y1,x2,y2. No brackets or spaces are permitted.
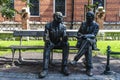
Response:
0,29,120,40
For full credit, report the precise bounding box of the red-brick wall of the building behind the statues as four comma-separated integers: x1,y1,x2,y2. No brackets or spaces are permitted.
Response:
0,0,120,28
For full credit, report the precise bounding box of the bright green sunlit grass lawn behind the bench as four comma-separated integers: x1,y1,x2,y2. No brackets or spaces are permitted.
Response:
0,40,120,57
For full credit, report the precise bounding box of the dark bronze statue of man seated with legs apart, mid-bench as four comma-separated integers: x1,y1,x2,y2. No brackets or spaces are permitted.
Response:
39,12,69,78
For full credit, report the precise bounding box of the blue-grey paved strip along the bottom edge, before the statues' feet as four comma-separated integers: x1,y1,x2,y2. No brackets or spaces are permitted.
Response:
0,72,120,80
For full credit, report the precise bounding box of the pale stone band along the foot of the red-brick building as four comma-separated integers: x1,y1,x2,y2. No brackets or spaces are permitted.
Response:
0,21,120,31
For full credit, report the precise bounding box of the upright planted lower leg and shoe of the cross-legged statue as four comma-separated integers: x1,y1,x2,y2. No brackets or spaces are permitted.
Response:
85,44,93,76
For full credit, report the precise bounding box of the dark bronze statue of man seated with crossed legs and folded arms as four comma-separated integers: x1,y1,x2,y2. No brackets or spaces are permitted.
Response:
71,11,99,76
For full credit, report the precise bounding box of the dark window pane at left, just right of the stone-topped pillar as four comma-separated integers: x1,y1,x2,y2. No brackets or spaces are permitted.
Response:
29,0,39,16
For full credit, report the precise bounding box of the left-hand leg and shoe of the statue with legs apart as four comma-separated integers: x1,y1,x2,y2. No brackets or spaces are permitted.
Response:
39,46,51,78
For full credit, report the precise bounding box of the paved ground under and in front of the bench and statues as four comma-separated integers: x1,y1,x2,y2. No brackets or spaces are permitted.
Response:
0,53,120,80
